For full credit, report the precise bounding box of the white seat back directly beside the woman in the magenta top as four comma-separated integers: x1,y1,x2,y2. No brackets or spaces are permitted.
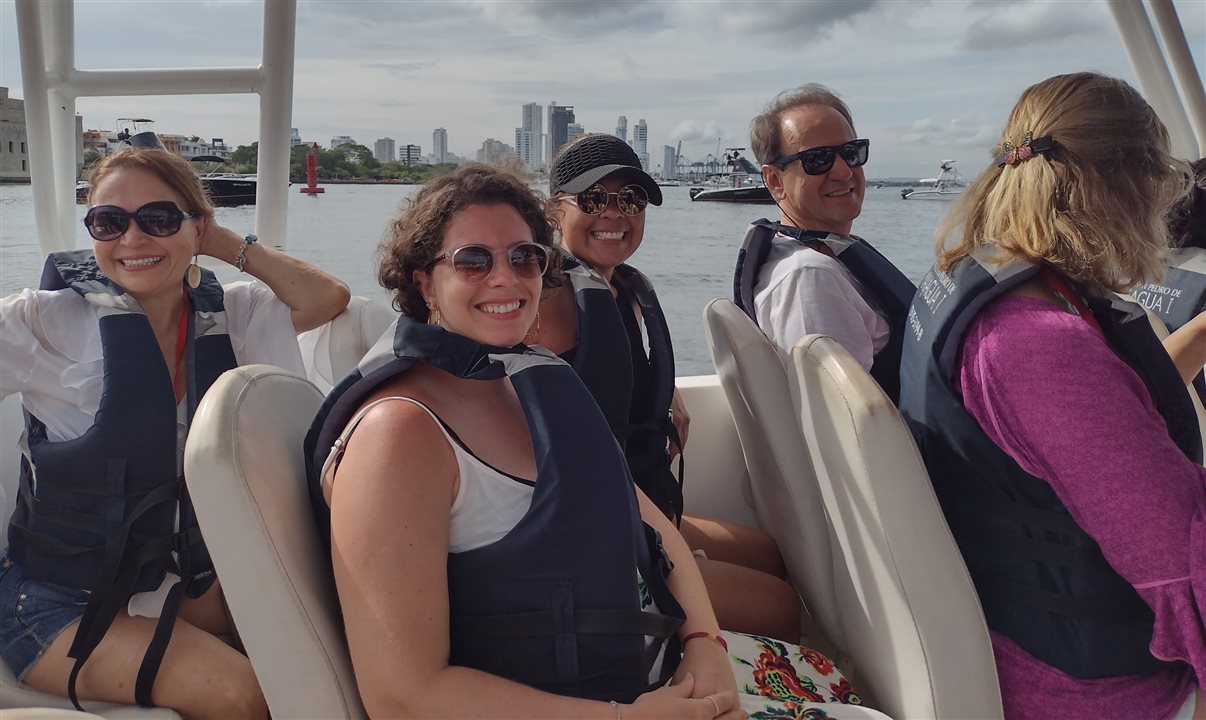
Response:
789,335,1002,719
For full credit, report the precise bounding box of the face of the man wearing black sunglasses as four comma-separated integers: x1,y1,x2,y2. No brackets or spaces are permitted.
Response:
762,105,867,235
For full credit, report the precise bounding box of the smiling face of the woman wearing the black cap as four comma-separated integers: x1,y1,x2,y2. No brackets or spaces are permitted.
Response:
557,170,645,280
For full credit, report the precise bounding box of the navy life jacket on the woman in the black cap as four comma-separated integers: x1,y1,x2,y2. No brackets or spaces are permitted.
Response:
562,254,683,521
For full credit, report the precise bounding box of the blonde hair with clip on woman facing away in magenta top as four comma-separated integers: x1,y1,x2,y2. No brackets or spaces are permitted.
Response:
936,72,1189,292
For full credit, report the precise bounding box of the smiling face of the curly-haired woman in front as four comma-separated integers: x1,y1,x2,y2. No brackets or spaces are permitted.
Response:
414,204,544,347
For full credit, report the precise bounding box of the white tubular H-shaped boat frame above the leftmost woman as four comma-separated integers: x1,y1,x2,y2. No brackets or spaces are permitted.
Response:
17,0,297,254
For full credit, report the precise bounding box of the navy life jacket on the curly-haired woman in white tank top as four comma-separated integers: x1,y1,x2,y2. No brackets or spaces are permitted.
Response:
306,316,684,701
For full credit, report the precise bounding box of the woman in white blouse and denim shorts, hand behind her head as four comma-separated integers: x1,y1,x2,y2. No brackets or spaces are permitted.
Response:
0,150,349,718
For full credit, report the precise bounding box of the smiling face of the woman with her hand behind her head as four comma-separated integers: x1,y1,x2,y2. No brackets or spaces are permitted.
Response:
90,168,205,308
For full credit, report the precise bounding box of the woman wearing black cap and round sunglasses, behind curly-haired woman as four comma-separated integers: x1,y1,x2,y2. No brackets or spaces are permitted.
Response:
534,134,800,642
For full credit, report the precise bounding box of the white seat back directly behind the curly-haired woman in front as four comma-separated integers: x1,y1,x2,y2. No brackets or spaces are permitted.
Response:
185,365,365,719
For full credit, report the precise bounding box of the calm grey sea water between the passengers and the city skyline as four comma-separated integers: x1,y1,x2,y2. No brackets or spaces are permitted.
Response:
0,185,950,375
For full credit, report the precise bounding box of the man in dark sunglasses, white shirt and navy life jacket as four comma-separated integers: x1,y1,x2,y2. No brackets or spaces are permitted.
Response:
734,84,915,402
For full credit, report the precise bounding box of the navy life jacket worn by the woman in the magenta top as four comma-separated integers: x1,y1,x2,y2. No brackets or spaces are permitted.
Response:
900,254,1202,678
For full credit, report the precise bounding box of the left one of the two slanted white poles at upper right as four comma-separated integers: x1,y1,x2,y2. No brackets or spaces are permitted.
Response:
1108,0,1199,158
